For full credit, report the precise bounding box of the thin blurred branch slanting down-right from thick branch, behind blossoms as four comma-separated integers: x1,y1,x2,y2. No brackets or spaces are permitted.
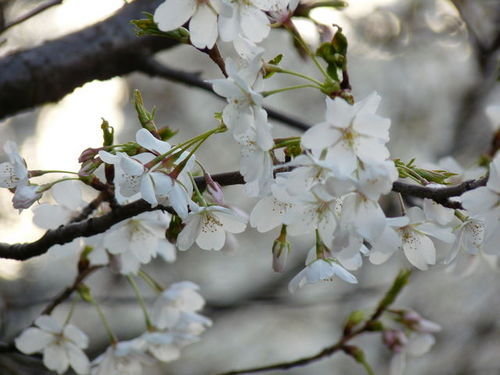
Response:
140,57,311,131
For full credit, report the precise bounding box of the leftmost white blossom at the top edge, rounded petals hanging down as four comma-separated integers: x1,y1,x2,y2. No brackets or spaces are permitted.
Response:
154,0,231,49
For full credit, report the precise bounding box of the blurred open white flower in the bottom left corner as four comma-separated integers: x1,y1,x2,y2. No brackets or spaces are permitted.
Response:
15,315,89,374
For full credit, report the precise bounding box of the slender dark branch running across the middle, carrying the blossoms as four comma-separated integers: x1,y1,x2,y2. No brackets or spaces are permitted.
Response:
0,168,487,260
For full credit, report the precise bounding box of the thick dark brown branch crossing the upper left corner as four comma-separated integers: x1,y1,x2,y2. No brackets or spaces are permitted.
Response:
0,0,178,119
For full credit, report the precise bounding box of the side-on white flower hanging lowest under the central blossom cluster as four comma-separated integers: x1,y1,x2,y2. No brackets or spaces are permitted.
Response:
288,253,358,293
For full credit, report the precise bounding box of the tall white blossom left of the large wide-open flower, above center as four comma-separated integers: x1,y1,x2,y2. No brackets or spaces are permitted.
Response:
209,55,273,151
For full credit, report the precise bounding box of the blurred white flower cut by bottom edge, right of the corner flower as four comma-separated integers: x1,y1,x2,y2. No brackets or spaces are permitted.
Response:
91,340,153,375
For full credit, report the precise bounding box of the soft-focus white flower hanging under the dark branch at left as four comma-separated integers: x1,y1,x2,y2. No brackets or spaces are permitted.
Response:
100,211,175,274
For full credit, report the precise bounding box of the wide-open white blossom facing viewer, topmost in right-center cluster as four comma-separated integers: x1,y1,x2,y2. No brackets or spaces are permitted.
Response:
302,92,391,177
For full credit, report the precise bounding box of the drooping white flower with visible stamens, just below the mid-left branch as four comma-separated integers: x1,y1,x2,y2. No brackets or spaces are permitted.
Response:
177,202,247,250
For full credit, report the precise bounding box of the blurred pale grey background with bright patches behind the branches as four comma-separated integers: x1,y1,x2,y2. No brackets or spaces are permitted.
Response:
0,0,500,375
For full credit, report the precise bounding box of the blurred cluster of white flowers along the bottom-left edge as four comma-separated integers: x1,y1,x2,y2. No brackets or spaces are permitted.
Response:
15,281,212,375
